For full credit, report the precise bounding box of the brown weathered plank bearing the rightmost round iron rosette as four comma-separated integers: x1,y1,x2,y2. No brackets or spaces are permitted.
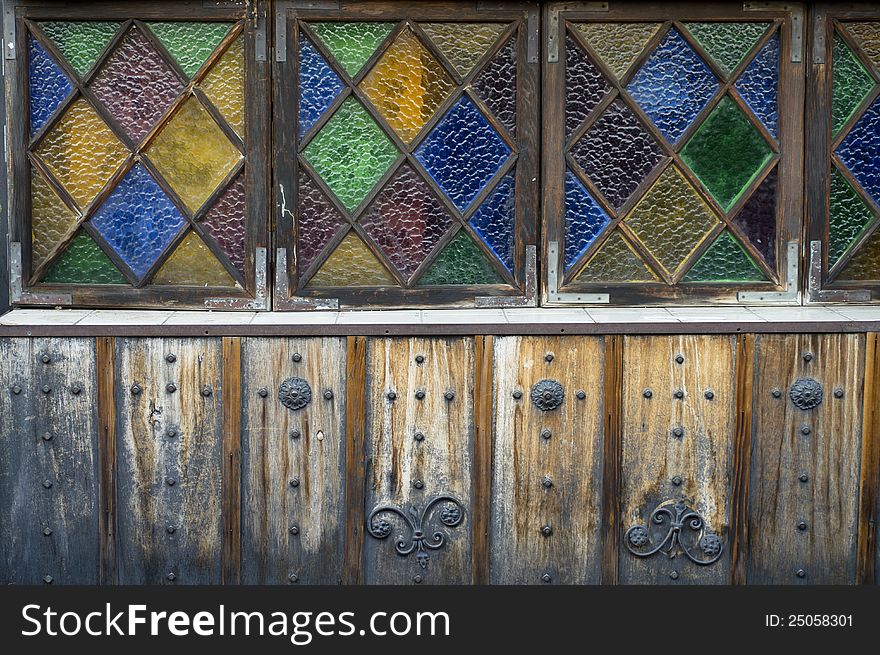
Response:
748,334,865,584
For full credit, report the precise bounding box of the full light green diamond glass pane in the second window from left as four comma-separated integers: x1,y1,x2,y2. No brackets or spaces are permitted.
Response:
304,97,397,211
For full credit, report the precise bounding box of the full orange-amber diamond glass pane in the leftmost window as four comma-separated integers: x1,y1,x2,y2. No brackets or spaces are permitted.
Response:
36,98,128,207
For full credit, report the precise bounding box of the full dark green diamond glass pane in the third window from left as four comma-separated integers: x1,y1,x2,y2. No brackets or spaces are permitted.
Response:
681,97,771,210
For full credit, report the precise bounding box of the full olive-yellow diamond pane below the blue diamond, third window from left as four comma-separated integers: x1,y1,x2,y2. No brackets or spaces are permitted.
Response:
626,166,719,274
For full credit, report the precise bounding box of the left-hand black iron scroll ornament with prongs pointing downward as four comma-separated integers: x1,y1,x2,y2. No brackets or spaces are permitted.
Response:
367,494,464,569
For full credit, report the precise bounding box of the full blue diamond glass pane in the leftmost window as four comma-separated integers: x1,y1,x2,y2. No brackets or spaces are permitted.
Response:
92,164,186,280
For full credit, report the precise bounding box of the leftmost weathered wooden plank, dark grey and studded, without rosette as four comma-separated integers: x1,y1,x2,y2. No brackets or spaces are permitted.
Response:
0,339,99,584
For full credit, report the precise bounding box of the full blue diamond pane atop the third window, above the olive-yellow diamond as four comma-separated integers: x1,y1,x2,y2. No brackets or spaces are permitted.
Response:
627,28,718,143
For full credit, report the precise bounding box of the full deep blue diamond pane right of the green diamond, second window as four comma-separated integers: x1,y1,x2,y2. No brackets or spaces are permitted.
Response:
415,96,510,211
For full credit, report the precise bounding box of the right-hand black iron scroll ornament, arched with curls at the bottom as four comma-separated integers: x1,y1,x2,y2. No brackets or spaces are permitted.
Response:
624,500,724,566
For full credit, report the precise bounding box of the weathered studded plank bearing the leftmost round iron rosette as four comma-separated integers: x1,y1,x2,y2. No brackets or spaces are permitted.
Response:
242,338,346,584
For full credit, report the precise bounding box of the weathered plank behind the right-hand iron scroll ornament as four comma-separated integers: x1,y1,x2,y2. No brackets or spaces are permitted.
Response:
620,336,735,584
